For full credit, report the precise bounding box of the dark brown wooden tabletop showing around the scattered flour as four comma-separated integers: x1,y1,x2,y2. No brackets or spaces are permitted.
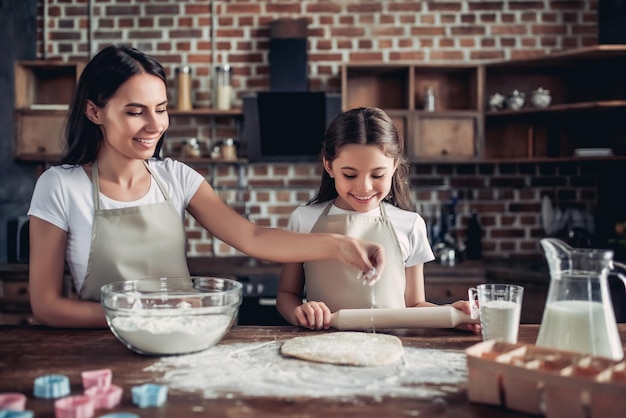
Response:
0,324,626,418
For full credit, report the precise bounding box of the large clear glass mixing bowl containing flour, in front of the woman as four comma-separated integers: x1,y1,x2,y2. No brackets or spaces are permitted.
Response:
101,277,242,356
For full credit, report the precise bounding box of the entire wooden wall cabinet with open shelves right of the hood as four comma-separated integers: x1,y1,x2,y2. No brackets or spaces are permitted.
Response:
341,45,626,163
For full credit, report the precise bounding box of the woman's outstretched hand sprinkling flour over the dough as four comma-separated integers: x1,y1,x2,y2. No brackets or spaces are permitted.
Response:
337,236,385,285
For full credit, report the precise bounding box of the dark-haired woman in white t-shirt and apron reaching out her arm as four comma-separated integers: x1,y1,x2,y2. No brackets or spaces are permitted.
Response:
28,46,383,327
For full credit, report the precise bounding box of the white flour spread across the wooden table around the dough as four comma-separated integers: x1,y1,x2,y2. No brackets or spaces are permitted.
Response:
146,341,467,399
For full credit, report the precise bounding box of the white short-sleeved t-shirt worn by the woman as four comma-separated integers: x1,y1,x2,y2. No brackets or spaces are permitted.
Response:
28,158,204,289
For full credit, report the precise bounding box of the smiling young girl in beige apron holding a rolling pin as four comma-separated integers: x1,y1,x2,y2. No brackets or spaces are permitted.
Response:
277,108,478,331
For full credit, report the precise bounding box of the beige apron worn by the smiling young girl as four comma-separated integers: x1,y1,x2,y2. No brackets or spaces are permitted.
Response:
304,201,406,312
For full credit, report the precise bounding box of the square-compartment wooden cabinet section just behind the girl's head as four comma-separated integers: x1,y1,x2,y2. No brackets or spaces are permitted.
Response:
341,63,483,161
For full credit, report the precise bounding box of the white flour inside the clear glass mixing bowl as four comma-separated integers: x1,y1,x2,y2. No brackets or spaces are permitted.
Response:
111,315,232,355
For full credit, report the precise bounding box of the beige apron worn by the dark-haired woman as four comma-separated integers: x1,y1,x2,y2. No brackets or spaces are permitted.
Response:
79,162,189,301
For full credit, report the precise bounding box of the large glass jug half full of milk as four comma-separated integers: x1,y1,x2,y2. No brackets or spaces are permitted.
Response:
536,238,626,360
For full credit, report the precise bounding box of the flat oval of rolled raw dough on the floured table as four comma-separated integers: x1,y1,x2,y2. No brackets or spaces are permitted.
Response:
280,332,404,366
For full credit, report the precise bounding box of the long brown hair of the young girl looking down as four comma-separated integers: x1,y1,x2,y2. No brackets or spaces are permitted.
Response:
308,107,412,210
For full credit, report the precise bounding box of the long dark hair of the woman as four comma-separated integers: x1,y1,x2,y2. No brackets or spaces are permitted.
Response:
60,45,167,165
